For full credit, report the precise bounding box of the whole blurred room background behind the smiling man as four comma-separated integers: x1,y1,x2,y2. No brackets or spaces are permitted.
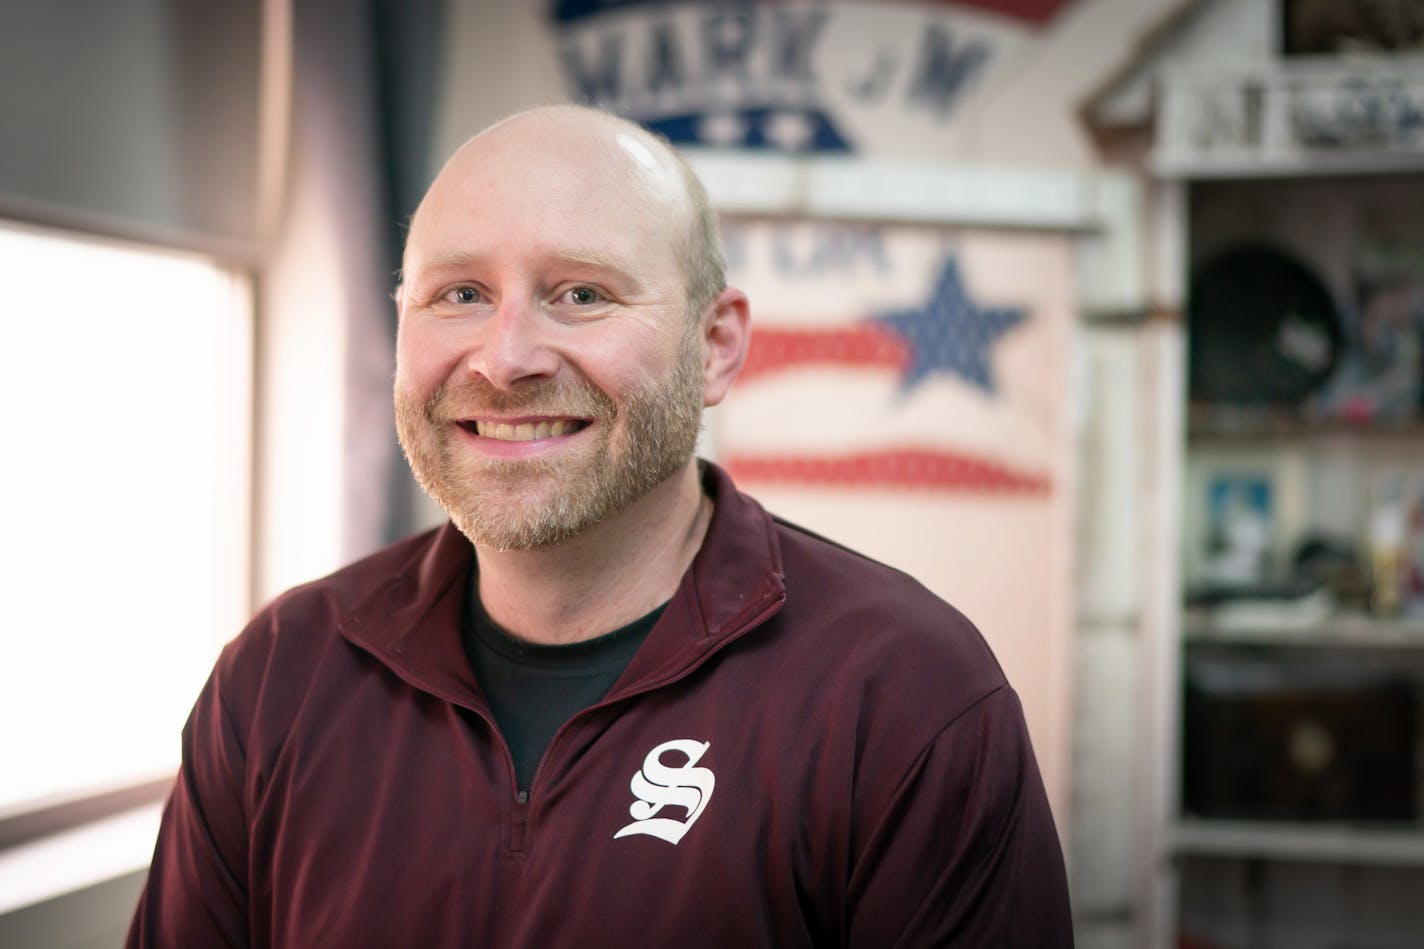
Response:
0,0,1424,949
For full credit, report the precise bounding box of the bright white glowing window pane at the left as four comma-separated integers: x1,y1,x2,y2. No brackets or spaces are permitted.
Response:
0,224,252,814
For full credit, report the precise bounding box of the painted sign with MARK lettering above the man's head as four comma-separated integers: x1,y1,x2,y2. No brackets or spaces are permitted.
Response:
550,0,1067,152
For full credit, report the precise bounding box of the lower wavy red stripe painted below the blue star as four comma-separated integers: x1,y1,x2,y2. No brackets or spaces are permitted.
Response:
725,449,1049,494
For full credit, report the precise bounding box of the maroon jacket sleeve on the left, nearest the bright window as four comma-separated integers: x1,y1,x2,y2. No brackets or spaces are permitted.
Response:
125,661,251,949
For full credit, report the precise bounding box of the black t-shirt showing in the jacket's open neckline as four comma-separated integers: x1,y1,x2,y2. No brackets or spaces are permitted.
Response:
461,577,666,791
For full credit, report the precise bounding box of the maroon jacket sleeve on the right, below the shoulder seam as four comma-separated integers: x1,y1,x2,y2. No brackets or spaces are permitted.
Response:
849,687,1072,949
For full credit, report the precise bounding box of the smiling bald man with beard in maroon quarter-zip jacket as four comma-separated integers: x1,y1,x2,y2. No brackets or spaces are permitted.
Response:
130,107,1071,949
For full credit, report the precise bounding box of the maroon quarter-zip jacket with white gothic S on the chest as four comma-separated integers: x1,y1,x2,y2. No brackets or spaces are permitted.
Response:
128,465,1072,949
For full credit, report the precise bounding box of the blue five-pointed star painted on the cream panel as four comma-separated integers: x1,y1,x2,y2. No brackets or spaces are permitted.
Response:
870,256,1027,395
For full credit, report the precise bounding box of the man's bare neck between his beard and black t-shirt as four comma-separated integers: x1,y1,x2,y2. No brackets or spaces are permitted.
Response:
476,462,712,644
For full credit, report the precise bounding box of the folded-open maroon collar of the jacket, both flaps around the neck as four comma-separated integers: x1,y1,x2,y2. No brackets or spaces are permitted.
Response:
339,462,786,707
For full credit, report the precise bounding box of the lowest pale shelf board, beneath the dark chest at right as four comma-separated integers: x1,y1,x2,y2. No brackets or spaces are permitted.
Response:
1172,818,1424,866
